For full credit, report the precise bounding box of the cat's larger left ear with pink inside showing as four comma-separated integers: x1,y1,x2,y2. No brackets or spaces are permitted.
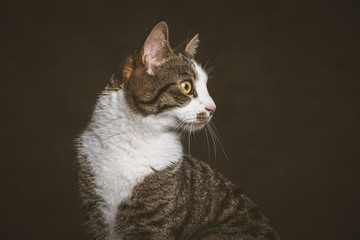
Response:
141,21,171,74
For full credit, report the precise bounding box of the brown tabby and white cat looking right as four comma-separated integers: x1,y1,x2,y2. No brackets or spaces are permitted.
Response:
77,22,280,240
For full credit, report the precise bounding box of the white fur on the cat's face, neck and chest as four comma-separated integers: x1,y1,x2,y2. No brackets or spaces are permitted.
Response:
79,62,215,239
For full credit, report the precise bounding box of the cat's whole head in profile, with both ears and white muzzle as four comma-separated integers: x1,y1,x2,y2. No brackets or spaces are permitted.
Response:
114,22,216,130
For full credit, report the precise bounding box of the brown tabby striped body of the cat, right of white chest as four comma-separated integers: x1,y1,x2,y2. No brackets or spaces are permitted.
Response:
116,157,279,240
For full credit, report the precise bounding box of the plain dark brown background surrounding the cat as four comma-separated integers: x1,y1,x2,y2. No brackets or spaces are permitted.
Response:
0,1,360,240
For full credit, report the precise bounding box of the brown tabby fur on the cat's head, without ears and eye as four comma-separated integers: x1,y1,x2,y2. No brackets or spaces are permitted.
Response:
115,47,197,116
